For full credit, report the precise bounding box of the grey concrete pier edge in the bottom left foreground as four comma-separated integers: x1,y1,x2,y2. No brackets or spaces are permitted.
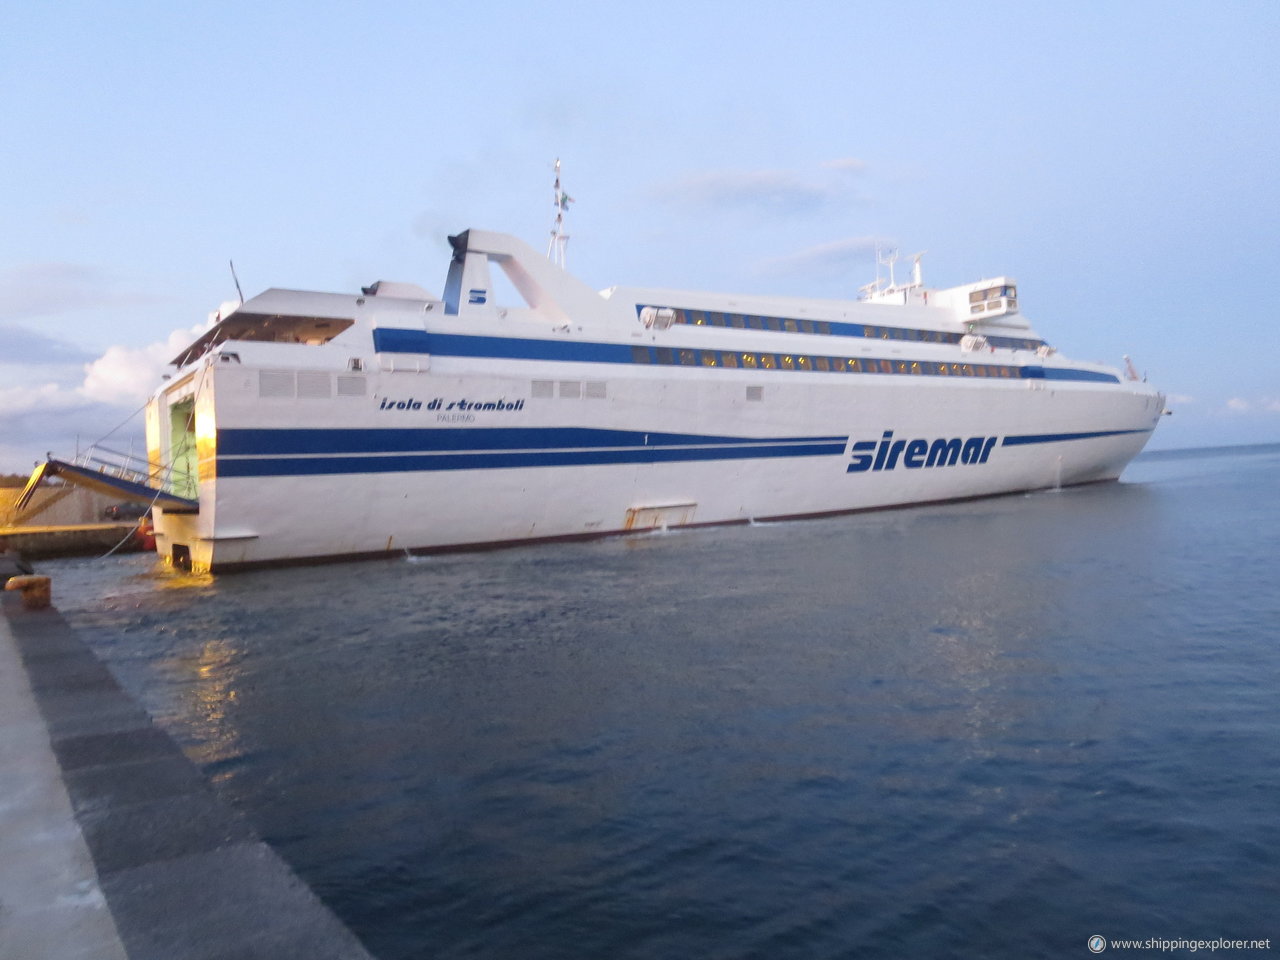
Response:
0,594,371,960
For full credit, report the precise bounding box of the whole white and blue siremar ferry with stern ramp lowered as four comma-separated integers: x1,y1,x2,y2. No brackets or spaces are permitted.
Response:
17,229,1165,572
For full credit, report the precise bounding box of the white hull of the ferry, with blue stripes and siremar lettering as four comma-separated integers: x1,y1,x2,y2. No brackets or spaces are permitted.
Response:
148,229,1164,571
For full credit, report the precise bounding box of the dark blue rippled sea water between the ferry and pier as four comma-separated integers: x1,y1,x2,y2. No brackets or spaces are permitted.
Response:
44,445,1280,960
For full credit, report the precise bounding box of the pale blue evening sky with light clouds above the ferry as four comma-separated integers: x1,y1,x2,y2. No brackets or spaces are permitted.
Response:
0,0,1280,472
